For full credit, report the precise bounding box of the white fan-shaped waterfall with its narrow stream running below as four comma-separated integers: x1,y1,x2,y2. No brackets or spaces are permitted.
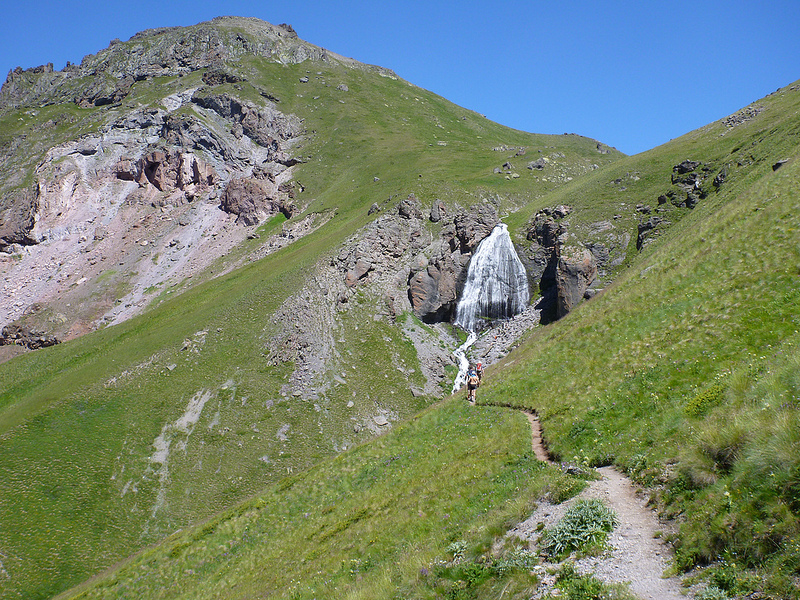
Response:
452,223,530,394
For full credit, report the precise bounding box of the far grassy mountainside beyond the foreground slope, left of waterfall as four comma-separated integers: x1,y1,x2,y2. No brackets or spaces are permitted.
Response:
0,42,618,598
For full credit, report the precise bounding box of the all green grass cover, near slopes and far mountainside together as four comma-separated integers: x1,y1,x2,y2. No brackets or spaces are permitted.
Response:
0,16,800,599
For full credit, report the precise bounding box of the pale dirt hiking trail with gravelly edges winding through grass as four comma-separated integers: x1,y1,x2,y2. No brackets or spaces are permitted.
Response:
509,412,687,600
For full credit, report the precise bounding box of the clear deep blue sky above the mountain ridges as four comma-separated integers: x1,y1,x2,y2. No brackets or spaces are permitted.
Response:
0,0,800,154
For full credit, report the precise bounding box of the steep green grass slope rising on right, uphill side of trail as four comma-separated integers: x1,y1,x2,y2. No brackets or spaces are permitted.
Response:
481,81,800,597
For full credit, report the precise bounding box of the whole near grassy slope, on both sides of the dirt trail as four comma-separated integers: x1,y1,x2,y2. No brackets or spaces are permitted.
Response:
54,79,800,598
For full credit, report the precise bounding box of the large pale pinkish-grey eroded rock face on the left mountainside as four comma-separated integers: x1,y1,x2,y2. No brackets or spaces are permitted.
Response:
0,84,304,348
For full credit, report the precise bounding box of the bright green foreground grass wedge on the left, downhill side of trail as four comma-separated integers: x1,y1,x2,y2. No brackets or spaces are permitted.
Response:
63,400,583,598
